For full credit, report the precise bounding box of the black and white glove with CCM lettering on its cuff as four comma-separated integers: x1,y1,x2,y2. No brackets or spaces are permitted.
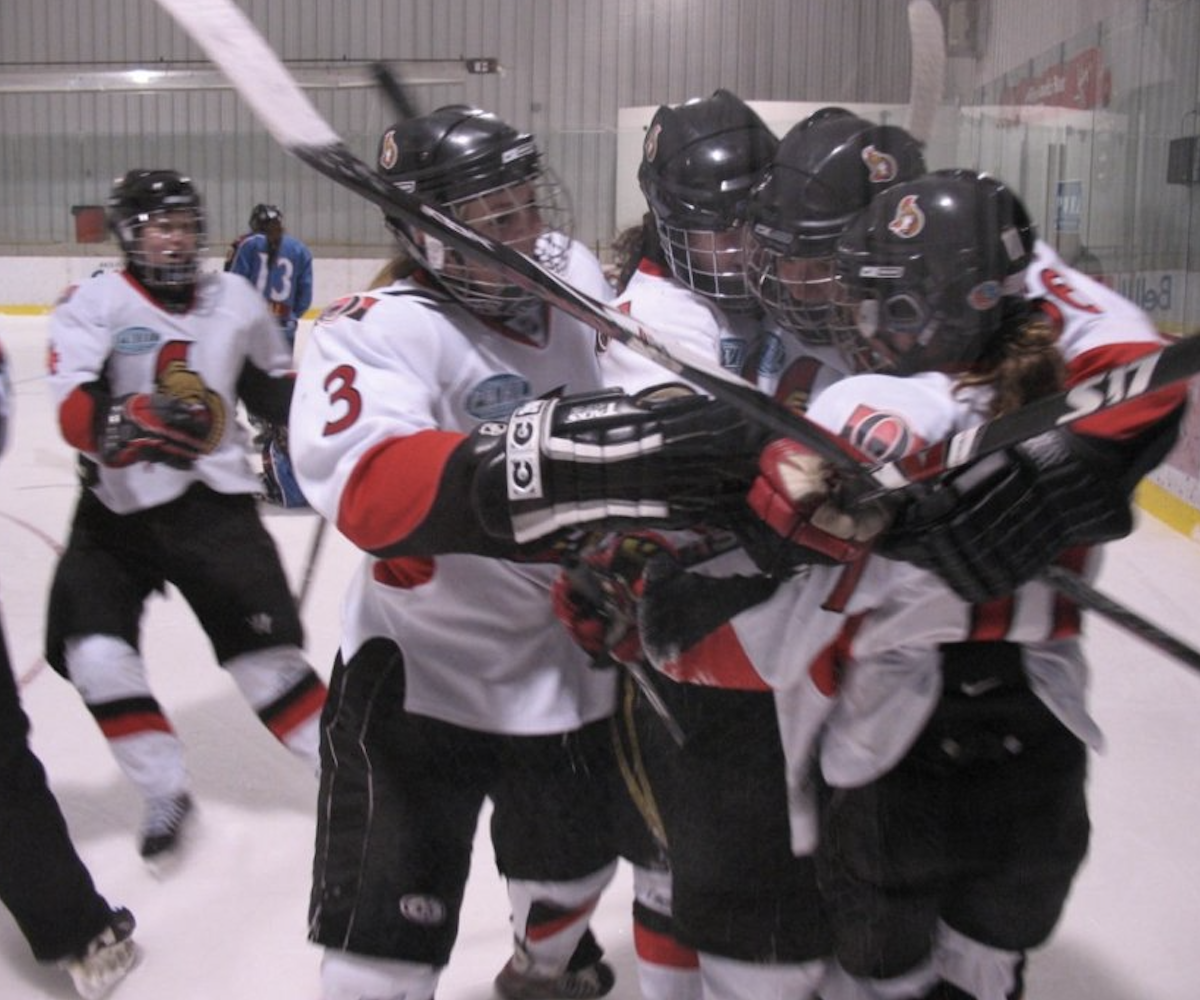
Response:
472,389,762,544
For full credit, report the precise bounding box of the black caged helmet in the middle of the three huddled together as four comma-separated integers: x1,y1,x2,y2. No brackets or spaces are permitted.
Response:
746,107,925,343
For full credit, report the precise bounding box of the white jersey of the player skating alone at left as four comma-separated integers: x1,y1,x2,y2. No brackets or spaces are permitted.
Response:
48,273,292,514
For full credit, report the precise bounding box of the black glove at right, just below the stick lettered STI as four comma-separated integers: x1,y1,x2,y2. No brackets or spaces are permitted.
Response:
878,430,1174,603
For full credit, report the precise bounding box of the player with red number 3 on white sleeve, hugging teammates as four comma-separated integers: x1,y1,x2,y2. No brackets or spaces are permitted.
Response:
289,106,744,1000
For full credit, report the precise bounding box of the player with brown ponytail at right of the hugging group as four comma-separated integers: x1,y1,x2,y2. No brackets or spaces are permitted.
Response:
681,170,1183,1000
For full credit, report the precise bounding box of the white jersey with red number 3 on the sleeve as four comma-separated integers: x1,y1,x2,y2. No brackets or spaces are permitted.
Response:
290,244,616,735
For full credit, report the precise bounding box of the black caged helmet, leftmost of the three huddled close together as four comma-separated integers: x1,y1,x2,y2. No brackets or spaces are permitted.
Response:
637,90,778,307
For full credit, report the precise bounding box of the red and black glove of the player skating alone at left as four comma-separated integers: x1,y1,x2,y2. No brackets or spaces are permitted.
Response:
96,393,214,468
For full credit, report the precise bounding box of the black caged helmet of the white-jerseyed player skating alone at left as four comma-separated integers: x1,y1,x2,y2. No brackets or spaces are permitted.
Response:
106,169,206,291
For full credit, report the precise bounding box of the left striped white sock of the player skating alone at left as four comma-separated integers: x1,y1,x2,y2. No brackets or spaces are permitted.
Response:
66,635,188,798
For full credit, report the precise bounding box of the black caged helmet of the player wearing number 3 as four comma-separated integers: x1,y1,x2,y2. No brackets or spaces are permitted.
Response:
378,104,574,317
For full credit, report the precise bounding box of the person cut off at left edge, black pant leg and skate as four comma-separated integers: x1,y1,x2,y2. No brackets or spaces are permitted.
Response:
0,338,138,1000
